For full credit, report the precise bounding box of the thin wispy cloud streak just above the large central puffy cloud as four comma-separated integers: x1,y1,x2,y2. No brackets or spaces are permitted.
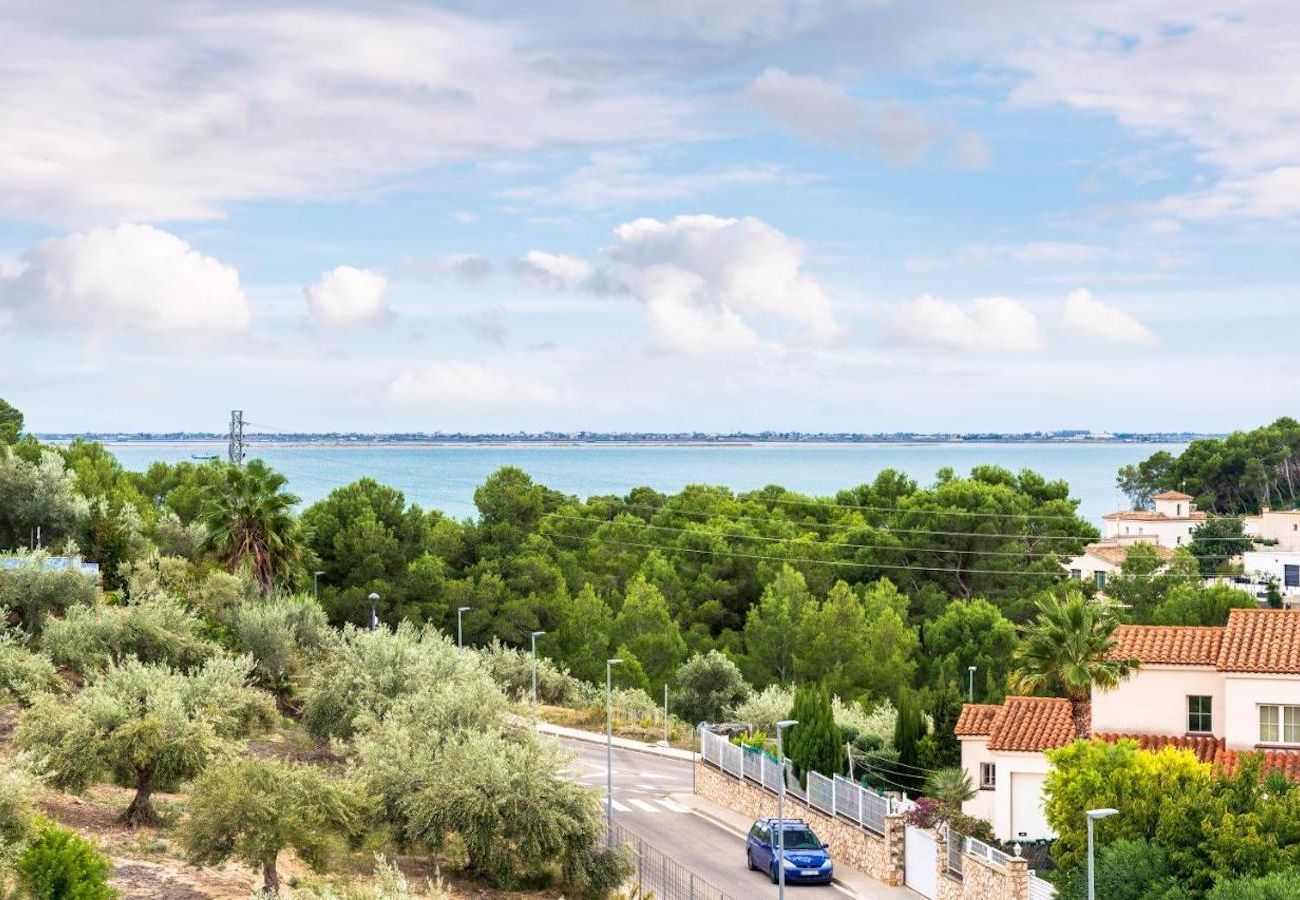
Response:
498,151,803,209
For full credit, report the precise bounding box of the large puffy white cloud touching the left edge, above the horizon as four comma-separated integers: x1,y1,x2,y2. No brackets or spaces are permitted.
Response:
0,225,252,337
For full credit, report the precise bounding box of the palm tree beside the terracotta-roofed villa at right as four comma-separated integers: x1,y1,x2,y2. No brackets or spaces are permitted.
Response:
1011,593,1138,737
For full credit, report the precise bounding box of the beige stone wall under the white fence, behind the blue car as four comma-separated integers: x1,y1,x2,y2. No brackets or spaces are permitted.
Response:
696,762,904,887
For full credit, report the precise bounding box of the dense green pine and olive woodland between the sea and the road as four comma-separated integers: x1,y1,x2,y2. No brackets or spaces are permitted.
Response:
0,402,1289,895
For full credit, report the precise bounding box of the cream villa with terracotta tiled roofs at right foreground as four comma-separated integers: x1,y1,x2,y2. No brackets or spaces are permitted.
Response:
956,609,1300,840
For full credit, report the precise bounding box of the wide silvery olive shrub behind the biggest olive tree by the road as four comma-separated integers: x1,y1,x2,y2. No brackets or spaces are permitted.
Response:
304,622,506,741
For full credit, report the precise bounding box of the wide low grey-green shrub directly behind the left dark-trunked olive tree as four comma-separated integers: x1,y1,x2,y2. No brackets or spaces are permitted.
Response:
40,596,217,675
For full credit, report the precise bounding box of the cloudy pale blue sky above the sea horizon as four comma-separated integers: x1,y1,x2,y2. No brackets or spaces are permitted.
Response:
0,0,1300,432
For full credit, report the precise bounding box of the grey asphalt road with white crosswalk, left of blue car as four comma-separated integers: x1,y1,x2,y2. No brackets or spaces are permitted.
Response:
562,740,844,900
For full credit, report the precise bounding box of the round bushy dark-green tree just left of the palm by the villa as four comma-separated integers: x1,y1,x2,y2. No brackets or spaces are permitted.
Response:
922,598,1018,704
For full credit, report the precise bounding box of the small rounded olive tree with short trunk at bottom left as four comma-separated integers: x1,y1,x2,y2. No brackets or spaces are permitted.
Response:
179,758,363,895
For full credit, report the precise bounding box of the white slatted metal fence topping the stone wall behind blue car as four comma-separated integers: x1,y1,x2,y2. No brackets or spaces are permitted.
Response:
699,728,909,836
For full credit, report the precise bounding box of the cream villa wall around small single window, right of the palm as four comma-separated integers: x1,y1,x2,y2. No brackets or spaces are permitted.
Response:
1092,665,1222,737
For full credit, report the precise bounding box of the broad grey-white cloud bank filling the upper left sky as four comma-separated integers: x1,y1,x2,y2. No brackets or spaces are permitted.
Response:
0,0,694,222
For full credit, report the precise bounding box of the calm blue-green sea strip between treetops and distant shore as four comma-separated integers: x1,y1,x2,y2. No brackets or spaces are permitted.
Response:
96,443,1184,522
